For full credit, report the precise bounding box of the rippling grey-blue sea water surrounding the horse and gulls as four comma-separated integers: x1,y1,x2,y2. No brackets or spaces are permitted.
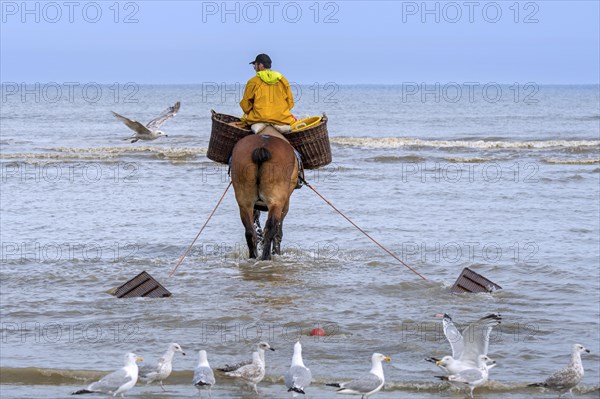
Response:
0,84,600,398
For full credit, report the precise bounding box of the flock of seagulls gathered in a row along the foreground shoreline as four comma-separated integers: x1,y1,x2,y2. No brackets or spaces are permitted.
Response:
72,313,590,399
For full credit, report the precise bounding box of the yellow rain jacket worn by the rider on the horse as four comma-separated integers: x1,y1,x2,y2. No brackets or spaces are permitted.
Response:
240,70,296,125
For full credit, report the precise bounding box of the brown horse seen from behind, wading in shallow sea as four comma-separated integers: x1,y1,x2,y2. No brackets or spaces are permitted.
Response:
231,134,298,260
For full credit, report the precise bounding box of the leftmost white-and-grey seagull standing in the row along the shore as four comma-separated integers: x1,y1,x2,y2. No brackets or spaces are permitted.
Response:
71,353,143,398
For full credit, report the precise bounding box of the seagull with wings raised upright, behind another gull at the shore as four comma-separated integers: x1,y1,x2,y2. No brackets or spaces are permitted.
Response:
425,313,502,374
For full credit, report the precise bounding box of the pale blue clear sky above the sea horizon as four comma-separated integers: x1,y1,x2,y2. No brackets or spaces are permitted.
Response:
0,0,600,84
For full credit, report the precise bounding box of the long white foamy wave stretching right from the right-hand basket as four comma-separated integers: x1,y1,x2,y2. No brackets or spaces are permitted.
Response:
330,137,600,150
